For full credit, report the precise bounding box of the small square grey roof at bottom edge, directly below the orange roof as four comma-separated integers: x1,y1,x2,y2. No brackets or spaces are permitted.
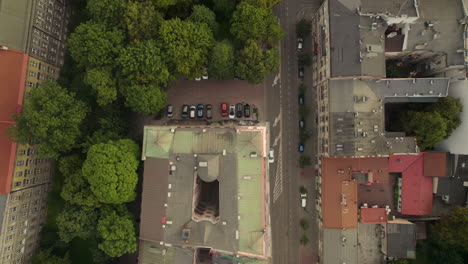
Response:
323,228,358,264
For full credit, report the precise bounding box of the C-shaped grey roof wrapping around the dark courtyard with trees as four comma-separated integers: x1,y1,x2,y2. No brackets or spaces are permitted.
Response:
329,78,449,156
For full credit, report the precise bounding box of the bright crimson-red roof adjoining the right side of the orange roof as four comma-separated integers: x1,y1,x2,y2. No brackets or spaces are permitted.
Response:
389,153,432,215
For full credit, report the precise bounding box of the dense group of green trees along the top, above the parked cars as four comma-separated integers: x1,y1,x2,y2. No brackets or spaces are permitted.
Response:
68,0,284,114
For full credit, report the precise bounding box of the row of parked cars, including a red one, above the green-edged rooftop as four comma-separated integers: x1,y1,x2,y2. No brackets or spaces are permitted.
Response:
166,103,250,119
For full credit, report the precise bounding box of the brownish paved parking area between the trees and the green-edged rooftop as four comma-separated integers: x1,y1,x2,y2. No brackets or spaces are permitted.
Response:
161,80,265,122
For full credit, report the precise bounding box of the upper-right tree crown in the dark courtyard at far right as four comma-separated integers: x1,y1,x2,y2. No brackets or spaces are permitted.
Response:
429,96,463,137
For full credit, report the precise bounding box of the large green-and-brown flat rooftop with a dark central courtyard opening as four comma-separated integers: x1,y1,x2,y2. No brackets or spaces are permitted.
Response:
140,126,269,259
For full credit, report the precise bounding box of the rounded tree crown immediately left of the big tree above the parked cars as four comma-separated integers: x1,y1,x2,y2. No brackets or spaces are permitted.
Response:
117,40,171,86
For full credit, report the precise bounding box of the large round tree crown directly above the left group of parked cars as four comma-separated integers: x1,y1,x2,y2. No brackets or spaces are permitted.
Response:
159,18,214,78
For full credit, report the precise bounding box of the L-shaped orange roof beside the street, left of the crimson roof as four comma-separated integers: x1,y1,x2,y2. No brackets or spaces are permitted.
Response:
322,158,388,229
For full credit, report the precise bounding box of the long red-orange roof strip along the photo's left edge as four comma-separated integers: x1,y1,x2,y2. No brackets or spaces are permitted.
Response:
0,50,28,194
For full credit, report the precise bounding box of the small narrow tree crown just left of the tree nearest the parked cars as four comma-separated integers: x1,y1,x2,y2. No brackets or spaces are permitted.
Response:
84,67,117,105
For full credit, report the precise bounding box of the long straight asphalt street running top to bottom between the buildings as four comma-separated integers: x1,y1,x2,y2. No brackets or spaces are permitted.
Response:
265,0,320,264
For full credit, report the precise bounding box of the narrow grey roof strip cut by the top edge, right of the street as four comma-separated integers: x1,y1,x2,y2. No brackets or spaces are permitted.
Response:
360,0,417,17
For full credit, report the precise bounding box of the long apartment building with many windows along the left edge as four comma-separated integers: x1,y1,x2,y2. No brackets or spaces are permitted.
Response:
0,0,70,264
